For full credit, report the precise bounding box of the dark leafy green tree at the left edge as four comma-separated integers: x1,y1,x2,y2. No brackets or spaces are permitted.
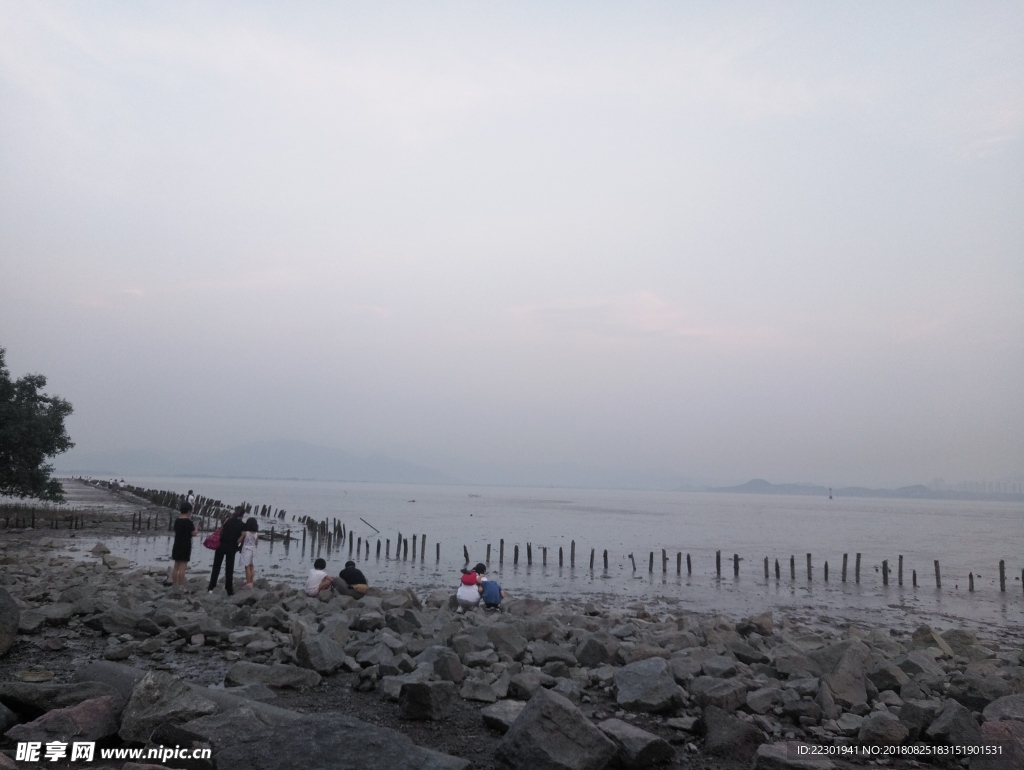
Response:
0,347,75,502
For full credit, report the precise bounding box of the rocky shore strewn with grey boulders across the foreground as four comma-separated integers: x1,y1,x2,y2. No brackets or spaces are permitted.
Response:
0,483,1024,770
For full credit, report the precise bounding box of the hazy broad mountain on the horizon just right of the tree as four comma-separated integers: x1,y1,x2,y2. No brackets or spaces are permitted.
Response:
55,440,458,484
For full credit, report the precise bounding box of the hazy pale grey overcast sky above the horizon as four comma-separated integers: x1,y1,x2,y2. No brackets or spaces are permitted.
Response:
0,0,1024,485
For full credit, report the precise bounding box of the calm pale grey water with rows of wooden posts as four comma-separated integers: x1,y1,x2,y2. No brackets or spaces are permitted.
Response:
94,478,1024,630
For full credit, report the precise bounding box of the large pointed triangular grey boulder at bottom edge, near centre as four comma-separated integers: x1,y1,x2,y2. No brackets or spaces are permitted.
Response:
498,690,617,770
